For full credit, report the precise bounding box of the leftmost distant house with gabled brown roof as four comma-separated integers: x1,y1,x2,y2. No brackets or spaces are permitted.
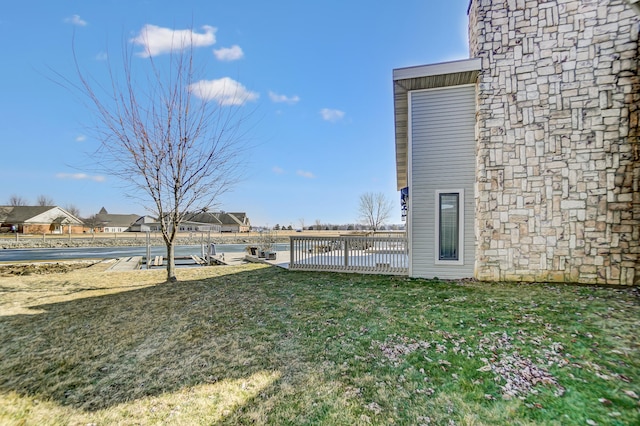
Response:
0,206,84,234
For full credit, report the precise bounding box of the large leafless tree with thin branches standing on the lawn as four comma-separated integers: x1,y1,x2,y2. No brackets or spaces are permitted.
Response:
65,31,246,282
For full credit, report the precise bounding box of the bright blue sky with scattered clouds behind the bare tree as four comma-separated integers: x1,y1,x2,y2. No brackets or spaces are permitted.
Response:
0,0,468,227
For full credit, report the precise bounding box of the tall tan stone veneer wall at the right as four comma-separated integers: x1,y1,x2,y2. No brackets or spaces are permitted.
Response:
469,0,640,285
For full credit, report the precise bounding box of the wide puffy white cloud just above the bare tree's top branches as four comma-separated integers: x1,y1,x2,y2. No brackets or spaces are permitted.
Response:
131,24,217,58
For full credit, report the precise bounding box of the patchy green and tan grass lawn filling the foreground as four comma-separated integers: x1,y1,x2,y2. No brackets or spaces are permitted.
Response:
0,265,640,425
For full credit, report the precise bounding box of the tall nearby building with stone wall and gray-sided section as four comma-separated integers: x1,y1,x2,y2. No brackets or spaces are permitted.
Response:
393,0,640,285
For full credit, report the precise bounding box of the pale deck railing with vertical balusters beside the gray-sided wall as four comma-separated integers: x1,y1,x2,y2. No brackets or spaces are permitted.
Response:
289,236,409,275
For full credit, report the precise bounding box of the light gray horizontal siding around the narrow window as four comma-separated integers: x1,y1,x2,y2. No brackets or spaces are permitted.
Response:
409,86,476,279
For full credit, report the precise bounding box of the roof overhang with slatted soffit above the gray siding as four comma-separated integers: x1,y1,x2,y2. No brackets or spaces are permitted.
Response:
393,58,482,190
